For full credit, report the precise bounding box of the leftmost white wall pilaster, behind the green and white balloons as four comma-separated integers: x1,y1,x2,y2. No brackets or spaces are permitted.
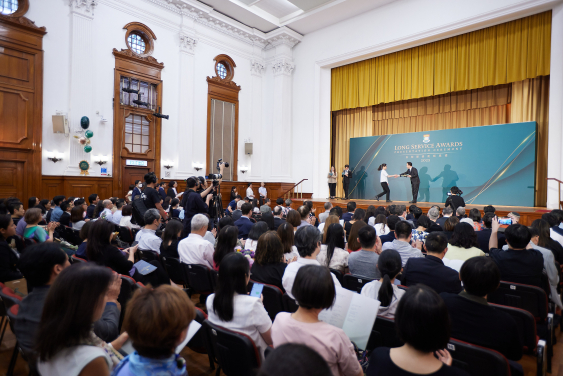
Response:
64,0,98,175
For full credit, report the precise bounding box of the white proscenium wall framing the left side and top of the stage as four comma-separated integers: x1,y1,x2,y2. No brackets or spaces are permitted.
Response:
293,0,558,198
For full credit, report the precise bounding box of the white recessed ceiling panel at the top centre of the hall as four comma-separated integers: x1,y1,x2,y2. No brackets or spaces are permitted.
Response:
199,0,396,35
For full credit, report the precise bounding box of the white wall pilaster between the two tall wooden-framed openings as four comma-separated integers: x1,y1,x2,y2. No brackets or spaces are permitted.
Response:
174,30,200,179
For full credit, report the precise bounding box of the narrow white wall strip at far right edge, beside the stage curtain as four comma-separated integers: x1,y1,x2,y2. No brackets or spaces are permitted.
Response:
547,4,563,209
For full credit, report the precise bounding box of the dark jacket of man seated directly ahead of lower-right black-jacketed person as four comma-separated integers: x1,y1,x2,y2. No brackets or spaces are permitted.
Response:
401,255,462,294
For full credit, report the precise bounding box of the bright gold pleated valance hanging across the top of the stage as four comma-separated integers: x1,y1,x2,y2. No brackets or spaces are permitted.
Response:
331,11,551,111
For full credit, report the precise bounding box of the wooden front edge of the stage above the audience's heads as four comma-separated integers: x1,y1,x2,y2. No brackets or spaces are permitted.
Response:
291,198,551,226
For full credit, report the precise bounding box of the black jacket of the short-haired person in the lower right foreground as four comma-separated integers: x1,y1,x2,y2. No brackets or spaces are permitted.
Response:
440,292,523,360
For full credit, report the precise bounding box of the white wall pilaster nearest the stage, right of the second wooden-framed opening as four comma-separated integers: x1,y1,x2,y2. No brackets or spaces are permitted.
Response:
270,53,295,181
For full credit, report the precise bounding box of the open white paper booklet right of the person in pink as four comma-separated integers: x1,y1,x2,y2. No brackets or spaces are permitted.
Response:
319,287,381,350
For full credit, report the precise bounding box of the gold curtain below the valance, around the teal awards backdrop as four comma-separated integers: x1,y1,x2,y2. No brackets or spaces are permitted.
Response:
327,76,549,206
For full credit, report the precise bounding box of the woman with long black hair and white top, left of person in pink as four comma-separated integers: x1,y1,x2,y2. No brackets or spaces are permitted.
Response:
207,252,272,358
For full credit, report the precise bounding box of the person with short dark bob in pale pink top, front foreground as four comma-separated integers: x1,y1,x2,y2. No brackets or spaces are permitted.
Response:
272,264,366,376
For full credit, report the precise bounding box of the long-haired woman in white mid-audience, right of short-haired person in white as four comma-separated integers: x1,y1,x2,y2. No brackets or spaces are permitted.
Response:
317,223,350,274
